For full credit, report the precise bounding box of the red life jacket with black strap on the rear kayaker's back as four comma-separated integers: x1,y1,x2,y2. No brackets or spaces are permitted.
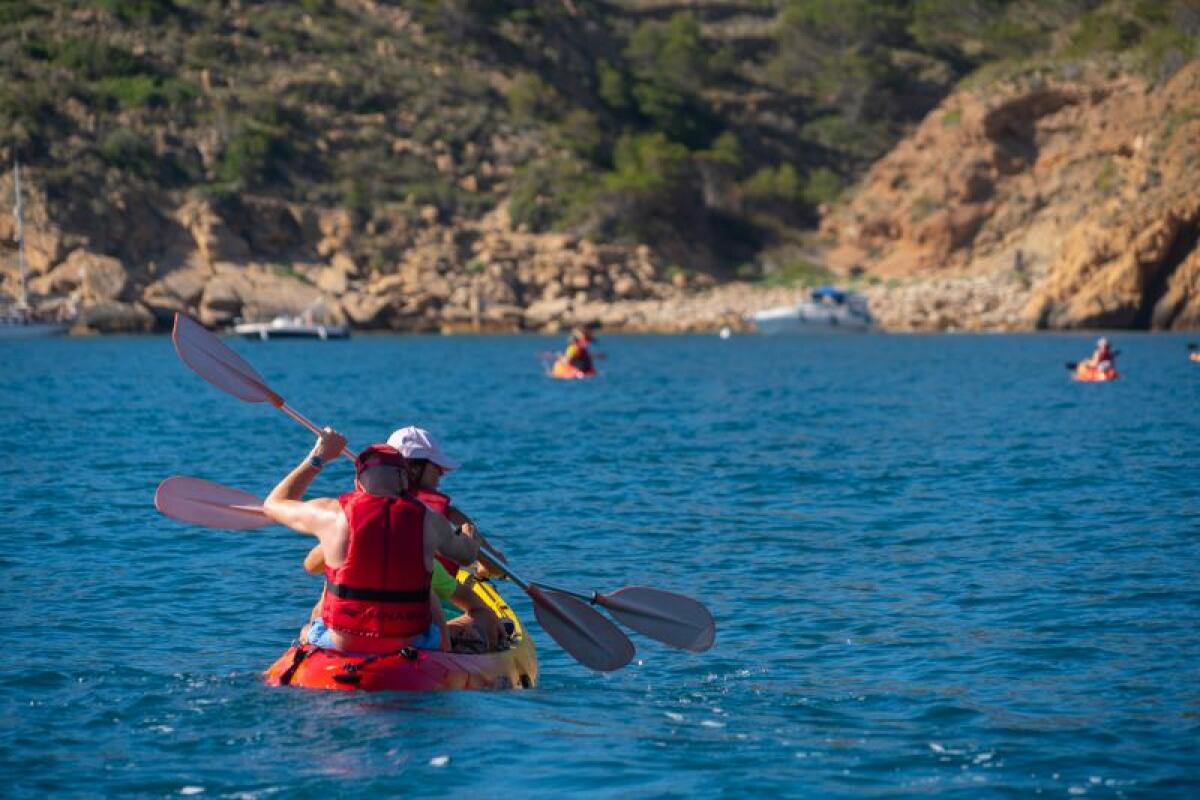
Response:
320,492,433,638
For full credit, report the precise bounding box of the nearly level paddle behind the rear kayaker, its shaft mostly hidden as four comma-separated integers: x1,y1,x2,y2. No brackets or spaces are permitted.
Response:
155,476,716,652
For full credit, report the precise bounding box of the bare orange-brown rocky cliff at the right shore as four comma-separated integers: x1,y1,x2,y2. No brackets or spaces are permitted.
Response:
821,62,1200,329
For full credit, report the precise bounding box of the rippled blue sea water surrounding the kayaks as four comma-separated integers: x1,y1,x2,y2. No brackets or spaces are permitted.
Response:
0,335,1200,798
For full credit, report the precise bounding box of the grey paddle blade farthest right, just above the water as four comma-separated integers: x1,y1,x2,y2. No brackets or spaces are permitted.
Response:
595,587,716,652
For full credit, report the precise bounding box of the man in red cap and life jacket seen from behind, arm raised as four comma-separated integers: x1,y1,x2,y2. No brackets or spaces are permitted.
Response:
263,428,479,654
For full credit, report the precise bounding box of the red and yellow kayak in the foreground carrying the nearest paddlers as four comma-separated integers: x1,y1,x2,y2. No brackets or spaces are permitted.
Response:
264,572,538,692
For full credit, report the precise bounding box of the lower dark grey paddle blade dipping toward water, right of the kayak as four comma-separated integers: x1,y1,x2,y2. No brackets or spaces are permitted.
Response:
526,584,634,672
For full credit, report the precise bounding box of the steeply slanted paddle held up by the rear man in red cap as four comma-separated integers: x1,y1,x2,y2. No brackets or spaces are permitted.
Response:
172,312,634,672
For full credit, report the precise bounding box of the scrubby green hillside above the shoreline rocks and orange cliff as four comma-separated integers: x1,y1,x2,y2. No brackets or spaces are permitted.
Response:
0,0,1200,276
